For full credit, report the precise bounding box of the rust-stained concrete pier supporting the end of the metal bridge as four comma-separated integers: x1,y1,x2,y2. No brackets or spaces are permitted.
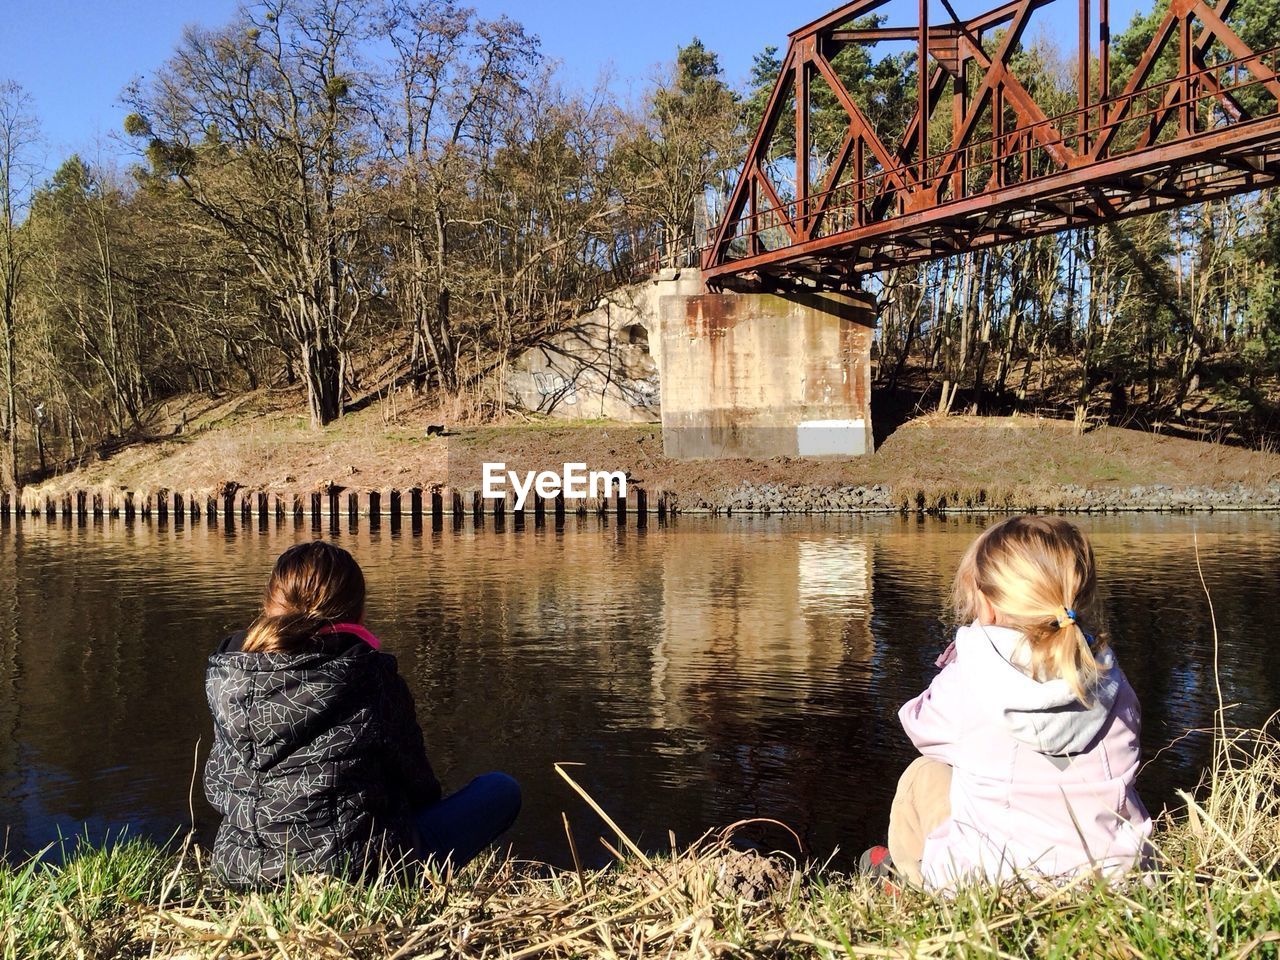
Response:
655,270,876,460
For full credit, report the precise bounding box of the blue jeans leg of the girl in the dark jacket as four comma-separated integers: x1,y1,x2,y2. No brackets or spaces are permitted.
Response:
413,773,520,869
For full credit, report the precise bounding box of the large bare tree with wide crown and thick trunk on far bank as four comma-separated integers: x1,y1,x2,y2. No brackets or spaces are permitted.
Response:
127,0,369,426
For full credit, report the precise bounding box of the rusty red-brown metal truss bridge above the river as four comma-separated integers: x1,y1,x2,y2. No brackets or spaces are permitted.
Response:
701,0,1280,289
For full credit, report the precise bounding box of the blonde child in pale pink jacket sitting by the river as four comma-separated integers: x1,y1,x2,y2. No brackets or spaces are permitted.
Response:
863,516,1151,890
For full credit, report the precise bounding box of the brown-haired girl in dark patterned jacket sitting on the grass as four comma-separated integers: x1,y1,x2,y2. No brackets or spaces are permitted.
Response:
205,541,520,886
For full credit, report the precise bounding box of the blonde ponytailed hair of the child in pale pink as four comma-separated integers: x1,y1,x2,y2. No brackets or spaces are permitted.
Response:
954,516,1107,704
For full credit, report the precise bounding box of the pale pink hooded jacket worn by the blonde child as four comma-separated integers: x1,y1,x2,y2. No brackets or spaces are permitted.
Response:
899,623,1151,888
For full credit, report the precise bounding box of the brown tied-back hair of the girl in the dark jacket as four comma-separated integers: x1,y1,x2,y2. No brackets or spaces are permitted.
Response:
241,540,365,653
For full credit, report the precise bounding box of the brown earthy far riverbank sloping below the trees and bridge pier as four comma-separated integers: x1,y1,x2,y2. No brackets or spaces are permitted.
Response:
17,393,1280,513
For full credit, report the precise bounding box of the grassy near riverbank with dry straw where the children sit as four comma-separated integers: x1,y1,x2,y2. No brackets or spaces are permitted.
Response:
10,731,1280,960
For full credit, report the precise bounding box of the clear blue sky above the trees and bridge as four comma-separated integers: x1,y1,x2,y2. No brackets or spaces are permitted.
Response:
0,0,1148,168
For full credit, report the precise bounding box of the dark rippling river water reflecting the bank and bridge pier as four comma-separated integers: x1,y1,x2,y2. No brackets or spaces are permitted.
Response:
0,516,1280,864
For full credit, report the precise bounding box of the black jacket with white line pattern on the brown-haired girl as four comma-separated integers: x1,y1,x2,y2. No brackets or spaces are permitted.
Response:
205,634,440,887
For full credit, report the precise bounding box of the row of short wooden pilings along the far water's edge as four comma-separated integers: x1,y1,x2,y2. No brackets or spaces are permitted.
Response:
0,486,673,529
